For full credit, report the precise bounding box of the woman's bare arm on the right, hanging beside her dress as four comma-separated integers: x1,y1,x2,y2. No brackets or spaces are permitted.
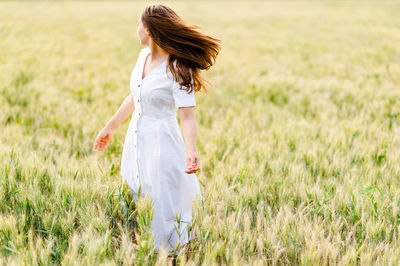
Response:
179,106,200,174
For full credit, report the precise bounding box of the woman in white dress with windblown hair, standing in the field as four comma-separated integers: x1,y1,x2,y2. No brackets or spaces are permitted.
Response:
94,5,221,256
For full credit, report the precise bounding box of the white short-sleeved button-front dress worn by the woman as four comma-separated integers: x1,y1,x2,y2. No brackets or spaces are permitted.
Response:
121,47,202,255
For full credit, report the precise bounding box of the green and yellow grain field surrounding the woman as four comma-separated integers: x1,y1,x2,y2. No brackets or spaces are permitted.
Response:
0,1,400,265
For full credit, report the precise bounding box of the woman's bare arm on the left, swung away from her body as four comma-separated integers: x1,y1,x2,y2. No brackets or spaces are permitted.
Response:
93,93,135,151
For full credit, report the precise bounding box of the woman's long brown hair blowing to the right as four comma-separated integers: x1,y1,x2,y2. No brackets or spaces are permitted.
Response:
141,5,221,93
